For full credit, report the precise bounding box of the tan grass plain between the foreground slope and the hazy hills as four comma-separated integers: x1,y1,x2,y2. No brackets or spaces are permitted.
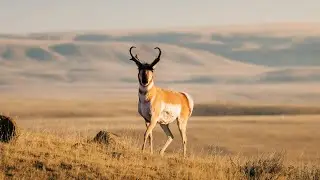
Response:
0,99,320,163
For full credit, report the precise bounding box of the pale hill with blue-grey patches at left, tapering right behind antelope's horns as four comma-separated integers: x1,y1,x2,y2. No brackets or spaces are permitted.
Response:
0,42,268,84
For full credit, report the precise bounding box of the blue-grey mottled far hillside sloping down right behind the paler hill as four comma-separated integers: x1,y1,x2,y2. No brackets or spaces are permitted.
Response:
68,32,320,67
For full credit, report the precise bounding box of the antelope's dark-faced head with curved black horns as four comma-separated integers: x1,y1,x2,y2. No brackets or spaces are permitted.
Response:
129,46,161,86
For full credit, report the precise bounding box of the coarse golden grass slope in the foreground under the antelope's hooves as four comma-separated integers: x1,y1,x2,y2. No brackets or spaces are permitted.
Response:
0,131,320,179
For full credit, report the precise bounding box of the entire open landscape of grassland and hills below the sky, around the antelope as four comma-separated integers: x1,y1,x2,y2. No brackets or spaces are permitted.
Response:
0,24,320,179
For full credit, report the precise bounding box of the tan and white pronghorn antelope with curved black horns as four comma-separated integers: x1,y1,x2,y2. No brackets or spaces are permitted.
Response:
129,46,194,157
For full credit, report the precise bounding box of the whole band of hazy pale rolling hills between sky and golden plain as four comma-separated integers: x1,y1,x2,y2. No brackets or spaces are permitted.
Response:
0,24,320,103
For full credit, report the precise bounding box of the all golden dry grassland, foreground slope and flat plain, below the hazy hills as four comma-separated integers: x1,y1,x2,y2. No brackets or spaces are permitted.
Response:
0,99,320,179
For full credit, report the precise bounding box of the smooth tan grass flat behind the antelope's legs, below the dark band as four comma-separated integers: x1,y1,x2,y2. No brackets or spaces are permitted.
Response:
10,115,320,164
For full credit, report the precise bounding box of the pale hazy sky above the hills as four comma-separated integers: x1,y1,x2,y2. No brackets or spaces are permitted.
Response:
0,0,320,33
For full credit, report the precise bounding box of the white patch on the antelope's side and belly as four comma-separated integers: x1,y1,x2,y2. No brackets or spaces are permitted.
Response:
158,102,181,124
